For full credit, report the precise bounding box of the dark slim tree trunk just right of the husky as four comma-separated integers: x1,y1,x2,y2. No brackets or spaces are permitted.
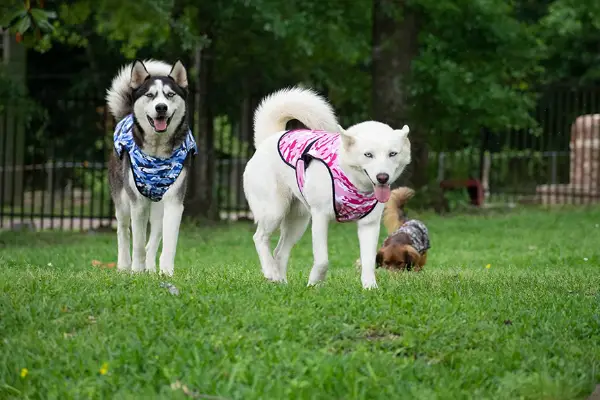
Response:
185,46,219,220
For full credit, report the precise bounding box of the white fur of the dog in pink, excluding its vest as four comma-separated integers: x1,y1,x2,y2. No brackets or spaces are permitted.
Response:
244,88,410,289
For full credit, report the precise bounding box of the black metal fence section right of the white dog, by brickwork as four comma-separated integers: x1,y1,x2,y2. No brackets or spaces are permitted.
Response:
430,85,600,205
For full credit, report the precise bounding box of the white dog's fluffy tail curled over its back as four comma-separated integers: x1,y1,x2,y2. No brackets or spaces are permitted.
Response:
254,87,338,147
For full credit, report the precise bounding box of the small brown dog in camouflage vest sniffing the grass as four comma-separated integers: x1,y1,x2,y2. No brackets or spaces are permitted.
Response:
376,187,430,271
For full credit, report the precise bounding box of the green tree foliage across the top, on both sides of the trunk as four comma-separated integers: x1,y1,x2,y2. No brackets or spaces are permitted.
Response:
3,0,600,147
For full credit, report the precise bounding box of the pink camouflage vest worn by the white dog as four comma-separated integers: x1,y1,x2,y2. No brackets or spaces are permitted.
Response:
278,129,377,222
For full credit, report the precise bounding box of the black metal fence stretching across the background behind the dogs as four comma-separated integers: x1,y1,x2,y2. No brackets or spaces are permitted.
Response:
0,82,600,230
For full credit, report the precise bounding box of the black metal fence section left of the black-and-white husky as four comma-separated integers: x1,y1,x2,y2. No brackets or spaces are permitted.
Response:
0,85,113,230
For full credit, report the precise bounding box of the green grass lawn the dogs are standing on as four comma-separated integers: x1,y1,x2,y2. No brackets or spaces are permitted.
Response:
0,209,600,399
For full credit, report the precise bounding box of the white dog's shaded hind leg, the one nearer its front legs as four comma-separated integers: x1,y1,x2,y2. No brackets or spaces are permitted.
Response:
273,201,310,281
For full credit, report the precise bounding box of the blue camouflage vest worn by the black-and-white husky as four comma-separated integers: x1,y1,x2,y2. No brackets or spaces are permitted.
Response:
113,114,198,202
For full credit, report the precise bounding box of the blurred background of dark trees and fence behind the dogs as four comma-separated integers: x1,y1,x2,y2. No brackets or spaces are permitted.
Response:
0,0,600,229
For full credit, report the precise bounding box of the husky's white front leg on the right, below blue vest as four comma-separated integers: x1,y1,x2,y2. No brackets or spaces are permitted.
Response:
159,198,183,276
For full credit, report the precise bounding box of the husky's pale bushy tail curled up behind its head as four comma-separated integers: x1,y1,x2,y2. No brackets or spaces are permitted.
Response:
106,60,173,121
